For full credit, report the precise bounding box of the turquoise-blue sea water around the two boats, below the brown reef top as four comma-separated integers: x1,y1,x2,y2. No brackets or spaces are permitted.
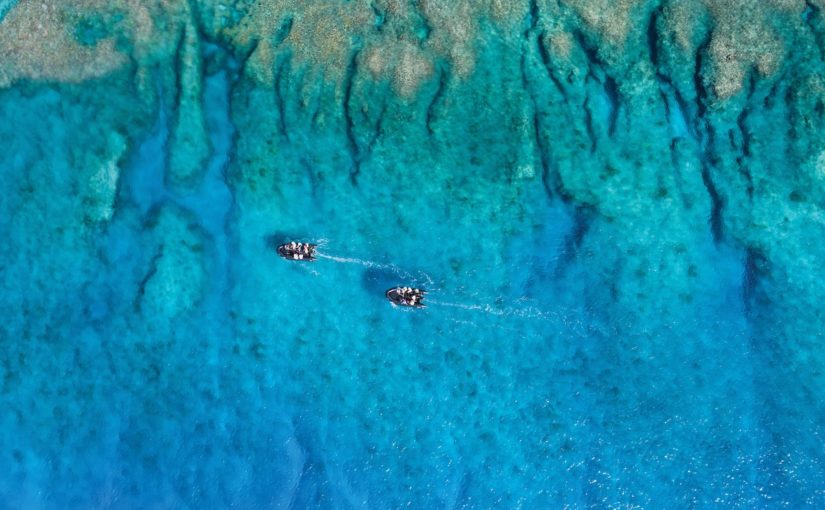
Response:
0,1,825,509
